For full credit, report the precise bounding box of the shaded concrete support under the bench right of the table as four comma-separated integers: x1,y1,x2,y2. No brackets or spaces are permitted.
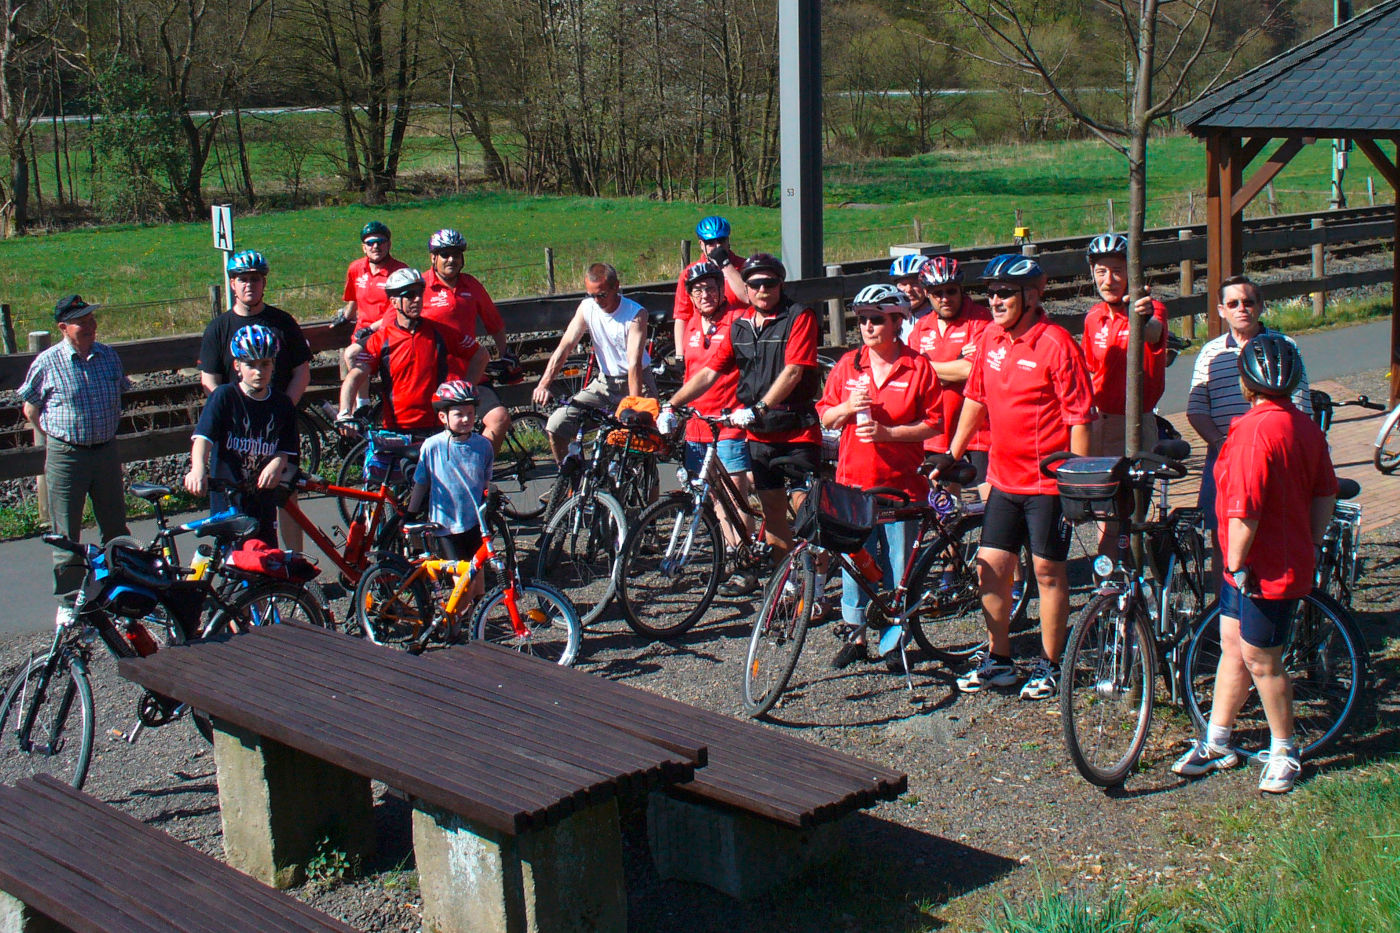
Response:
647,793,841,901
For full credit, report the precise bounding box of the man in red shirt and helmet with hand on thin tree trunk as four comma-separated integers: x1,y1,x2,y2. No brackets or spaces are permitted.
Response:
1084,234,1166,457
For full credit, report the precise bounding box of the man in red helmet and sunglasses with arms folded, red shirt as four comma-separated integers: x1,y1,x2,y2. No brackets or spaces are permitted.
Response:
909,256,991,487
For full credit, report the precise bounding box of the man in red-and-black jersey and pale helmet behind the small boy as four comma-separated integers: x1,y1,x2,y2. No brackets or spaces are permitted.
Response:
337,269,473,436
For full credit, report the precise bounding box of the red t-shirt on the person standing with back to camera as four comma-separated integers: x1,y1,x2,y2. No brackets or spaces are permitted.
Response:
1215,399,1337,600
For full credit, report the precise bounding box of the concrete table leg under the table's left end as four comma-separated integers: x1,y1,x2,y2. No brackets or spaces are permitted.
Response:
214,719,374,888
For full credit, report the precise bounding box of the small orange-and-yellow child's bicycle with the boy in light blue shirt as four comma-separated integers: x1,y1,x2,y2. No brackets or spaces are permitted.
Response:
354,493,582,667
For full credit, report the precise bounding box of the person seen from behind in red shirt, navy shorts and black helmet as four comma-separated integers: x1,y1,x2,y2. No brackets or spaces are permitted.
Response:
1172,332,1337,793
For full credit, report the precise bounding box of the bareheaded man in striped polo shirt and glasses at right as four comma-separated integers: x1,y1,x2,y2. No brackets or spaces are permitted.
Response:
1186,276,1312,574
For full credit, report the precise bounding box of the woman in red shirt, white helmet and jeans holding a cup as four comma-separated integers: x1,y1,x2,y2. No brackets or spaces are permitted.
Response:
816,284,938,670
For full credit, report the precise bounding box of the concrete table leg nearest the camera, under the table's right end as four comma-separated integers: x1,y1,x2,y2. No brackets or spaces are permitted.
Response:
413,800,627,933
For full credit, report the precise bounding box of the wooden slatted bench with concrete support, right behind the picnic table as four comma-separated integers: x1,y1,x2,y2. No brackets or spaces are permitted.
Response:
442,643,909,898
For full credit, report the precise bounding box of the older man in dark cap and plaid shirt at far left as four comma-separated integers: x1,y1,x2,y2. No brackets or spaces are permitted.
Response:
20,294,130,625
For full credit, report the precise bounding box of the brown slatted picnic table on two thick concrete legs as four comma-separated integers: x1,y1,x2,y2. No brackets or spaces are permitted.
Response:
120,625,706,930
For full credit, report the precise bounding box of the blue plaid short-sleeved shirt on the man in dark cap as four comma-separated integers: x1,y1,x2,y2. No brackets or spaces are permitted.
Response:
20,340,130,447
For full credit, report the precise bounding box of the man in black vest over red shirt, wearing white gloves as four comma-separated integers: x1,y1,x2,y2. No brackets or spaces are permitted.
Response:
668,252,822,558
